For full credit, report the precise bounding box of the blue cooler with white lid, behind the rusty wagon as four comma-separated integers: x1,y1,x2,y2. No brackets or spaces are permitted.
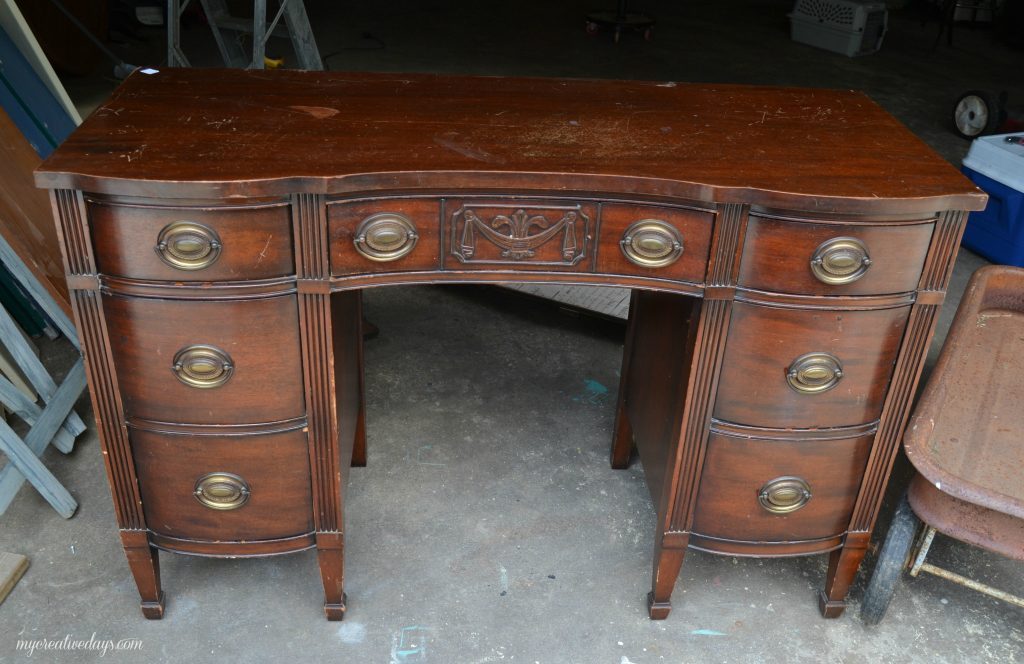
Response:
963,133,1024,267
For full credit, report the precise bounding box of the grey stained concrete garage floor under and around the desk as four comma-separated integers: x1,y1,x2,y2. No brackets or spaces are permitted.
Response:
0,0,1024,664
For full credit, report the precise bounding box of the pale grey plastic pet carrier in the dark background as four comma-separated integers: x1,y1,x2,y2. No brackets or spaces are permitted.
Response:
790,0,889,57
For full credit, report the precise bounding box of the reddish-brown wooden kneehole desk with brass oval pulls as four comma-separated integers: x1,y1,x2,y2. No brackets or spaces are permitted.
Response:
37,70,985,619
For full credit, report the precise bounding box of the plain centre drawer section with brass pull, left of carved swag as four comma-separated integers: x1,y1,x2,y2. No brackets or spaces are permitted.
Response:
327,199,440,275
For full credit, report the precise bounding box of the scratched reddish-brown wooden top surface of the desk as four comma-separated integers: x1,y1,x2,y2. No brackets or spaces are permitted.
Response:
37,70,984,211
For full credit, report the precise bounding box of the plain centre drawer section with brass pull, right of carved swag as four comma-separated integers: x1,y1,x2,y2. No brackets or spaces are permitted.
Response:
597,203,715,284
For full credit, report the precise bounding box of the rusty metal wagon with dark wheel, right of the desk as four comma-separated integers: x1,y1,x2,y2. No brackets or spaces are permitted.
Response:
860,265,1024,624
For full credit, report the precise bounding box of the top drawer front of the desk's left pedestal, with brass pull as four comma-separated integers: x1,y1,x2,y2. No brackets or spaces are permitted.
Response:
89,196,295,282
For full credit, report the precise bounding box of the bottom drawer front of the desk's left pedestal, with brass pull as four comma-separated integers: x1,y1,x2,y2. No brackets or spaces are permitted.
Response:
131,429,313,541
